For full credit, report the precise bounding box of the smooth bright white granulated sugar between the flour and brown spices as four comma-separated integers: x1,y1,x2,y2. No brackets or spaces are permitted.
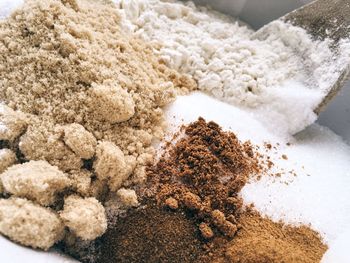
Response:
167,92,350,262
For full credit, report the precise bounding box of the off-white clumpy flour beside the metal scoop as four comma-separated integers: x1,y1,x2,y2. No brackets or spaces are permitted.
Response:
115,0,350,134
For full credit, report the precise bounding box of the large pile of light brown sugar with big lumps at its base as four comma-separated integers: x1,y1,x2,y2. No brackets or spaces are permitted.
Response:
0,0,196,253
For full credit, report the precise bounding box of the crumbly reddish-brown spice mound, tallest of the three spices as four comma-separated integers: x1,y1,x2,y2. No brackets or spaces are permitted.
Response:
147,118,261,239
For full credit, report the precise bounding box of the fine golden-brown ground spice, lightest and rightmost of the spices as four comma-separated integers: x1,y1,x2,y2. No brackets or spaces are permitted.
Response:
212,211,327,263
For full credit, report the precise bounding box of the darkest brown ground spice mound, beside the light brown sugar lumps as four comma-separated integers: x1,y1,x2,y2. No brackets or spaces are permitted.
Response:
95,207,203,263
